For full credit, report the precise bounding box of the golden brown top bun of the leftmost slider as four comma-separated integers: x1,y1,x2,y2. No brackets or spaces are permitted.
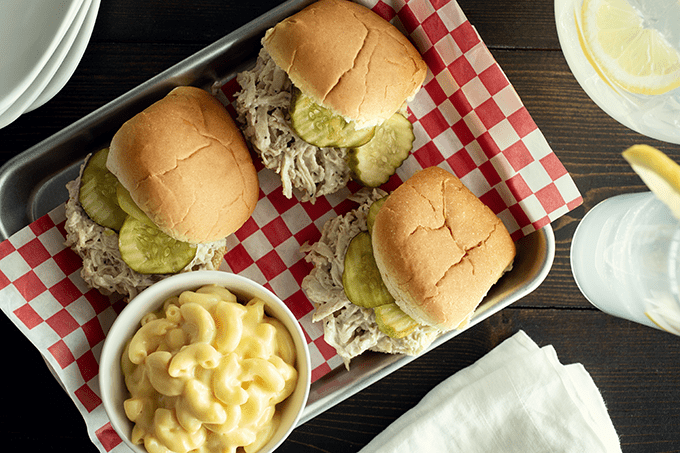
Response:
106,87,259,243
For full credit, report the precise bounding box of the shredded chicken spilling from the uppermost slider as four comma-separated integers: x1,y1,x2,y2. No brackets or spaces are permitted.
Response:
236,49,350,202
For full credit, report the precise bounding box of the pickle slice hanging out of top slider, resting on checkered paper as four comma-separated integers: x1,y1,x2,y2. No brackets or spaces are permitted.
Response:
347,113,415,187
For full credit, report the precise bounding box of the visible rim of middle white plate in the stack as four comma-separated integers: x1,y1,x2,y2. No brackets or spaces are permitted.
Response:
0,0,92,129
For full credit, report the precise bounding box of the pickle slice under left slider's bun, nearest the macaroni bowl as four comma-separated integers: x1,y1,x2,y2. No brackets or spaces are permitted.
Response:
118,215,196,274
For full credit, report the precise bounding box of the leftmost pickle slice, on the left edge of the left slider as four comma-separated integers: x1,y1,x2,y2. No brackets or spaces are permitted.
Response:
78,148,127,231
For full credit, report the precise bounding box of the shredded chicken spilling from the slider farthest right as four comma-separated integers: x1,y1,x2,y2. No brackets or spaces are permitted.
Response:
302,189,440,369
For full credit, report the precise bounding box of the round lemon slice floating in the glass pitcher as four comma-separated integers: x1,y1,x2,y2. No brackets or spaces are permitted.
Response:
577,0,680,95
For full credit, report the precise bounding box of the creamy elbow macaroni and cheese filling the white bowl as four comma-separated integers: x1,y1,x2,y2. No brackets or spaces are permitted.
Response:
121,285,298,453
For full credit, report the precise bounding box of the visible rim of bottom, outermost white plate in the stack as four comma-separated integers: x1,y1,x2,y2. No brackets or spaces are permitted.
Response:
24,0,101,113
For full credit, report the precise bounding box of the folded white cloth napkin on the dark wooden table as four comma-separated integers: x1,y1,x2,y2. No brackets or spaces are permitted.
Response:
360,331,621,453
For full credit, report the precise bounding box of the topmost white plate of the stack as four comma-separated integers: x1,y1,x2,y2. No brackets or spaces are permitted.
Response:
0,0,83,111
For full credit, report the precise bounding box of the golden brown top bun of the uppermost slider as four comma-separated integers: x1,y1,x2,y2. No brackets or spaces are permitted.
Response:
262,0,427,125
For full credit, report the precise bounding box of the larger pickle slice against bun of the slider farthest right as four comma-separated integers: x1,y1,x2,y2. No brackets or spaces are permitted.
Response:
342,231,394,308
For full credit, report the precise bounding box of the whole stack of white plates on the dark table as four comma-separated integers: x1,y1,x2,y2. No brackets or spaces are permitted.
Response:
0,0,101,128
